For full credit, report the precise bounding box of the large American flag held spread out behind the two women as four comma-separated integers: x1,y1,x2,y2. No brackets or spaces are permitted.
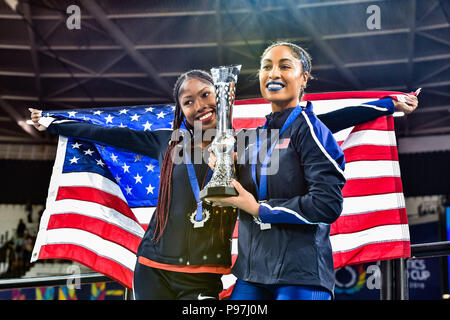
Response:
32,92,410,297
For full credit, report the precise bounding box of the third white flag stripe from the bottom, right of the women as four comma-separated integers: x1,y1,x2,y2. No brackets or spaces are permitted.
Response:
344,160,400,180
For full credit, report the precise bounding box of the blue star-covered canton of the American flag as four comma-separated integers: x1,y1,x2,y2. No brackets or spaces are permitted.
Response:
43,105,174,208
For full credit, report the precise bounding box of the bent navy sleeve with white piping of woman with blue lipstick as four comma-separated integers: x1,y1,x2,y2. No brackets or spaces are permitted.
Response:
259,111,345,224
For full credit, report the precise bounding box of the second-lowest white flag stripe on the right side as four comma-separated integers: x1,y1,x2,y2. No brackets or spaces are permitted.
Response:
341,193,405,216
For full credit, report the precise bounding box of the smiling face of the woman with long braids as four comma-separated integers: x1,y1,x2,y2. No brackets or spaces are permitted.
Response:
178,78,216,131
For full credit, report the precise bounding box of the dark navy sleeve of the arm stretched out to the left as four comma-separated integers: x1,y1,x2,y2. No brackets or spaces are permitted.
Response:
47,121,172,159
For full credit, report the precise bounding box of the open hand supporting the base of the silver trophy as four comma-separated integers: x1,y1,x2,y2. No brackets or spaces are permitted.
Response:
206,179,260,217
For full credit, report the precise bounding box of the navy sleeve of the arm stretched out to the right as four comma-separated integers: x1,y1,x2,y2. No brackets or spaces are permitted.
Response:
317,98,394,133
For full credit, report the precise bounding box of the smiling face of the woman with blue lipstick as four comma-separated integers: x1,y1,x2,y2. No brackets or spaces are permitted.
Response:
259,45,309,111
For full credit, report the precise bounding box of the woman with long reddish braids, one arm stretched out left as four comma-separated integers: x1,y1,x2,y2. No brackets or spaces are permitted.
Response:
31,70,237,300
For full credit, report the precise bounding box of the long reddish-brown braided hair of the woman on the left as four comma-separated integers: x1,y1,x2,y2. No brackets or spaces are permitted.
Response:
153,70,214,242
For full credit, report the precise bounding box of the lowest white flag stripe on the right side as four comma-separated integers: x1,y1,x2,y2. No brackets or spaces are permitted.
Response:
330,224,409,253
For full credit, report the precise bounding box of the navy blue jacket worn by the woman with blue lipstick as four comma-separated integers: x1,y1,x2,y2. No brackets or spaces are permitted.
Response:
232,99,393,293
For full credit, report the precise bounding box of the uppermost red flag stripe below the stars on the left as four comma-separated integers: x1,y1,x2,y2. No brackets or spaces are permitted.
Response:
56,187,137,221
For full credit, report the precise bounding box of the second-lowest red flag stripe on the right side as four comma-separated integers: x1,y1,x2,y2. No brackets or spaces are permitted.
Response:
330,208,408,236
